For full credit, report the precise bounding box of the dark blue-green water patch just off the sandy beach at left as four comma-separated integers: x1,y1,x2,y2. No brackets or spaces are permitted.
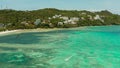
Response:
0,32,51,44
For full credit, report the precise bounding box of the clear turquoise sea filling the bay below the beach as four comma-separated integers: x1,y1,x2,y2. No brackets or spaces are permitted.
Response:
0,26,120,68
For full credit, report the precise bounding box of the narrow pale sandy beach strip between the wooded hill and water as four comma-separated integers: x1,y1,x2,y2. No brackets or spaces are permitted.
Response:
0,25,115,36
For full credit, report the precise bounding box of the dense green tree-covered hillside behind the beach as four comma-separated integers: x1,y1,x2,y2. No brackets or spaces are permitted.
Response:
0,8,120,31
